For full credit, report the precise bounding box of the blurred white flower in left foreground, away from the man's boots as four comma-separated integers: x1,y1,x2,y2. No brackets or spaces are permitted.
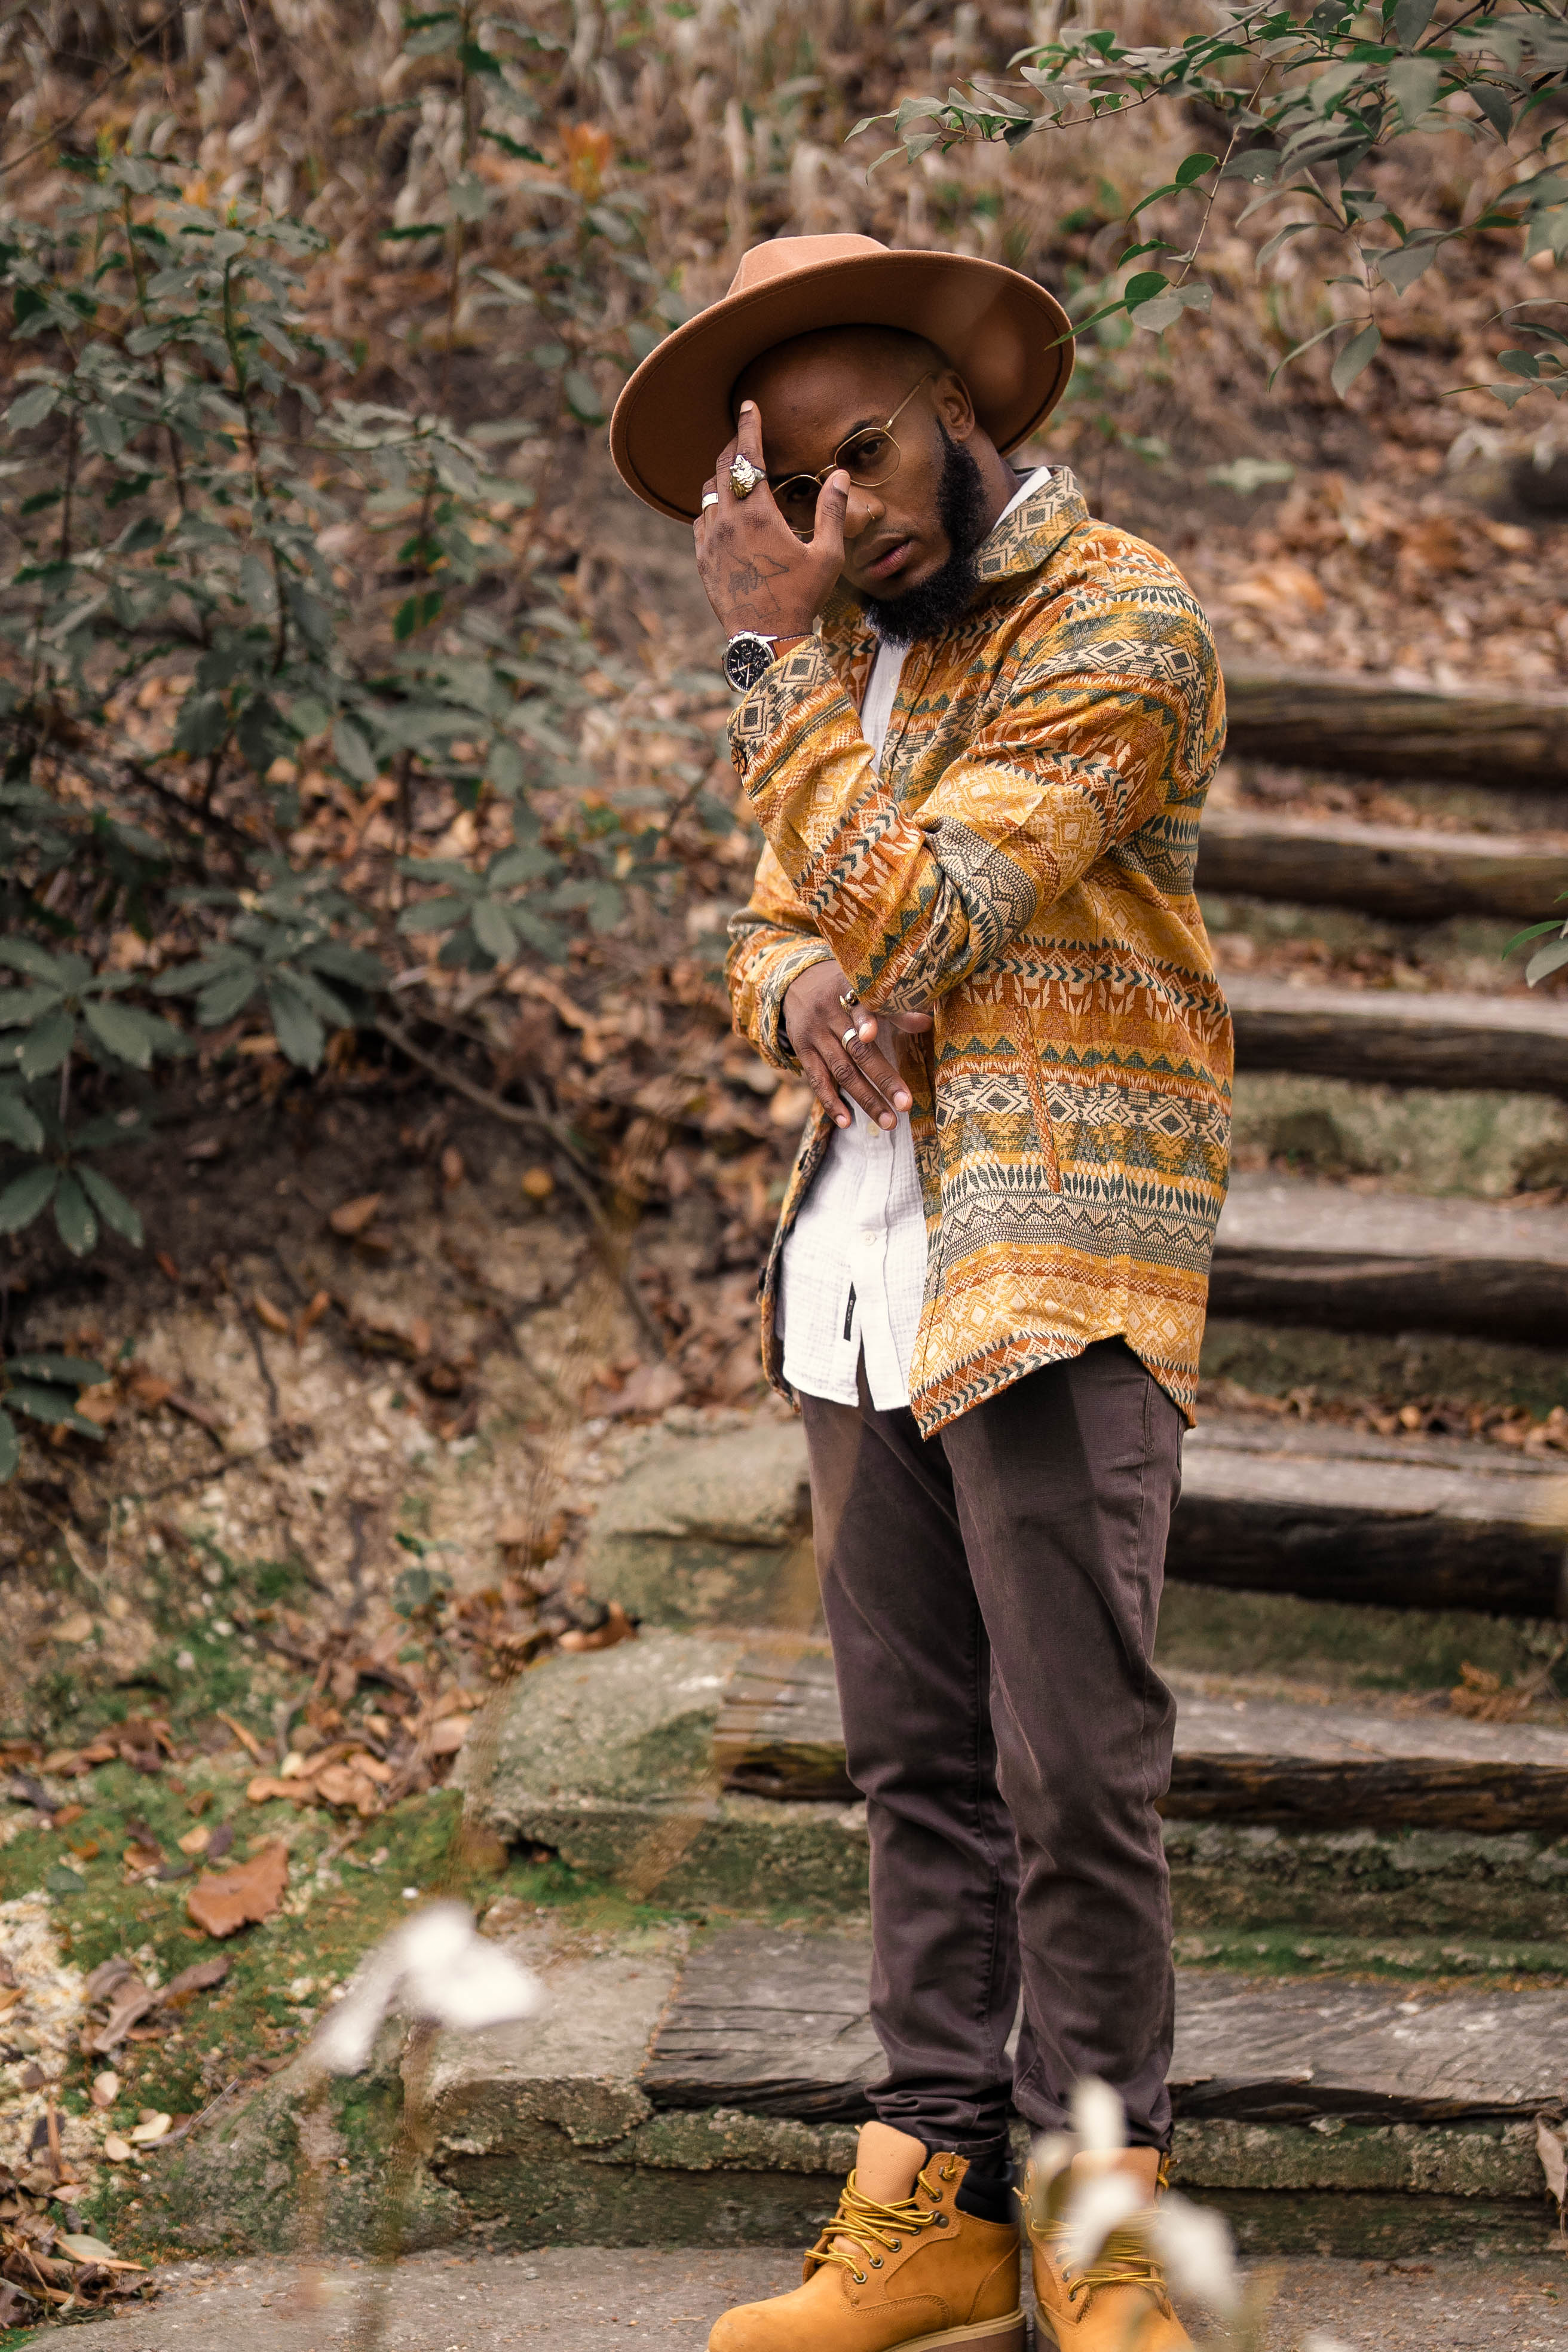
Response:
310,1903,546,2075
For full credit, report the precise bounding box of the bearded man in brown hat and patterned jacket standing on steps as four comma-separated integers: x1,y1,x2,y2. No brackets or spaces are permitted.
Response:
611,224,1232,2352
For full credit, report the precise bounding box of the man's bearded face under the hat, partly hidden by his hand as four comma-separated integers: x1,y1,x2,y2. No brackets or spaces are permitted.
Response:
736,334,976,605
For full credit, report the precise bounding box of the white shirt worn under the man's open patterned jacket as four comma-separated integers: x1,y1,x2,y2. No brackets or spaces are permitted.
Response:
778,466,1051,1414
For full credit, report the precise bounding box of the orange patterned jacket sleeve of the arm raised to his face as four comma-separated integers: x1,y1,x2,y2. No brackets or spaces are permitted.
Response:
731,611,1223,1007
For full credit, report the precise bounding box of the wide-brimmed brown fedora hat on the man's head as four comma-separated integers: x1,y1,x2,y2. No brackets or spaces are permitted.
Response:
609,238,1072,522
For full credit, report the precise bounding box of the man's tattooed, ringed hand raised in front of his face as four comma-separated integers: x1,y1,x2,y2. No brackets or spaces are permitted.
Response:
694,400,849,638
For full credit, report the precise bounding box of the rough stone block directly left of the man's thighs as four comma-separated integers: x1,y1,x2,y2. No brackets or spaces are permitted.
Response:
583,1420,816,1630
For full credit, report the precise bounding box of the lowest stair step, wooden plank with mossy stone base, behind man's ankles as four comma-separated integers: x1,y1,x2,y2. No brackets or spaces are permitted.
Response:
136,1903,1568,2260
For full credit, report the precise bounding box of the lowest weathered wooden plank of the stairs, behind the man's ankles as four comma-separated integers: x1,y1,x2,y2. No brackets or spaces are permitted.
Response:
639,1927,1568,2124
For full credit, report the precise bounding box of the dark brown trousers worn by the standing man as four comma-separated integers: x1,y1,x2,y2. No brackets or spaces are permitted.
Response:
802,1339,1183,2154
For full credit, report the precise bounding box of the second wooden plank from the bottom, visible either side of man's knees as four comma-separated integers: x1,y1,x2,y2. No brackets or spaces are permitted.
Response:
717,1651,1568,1837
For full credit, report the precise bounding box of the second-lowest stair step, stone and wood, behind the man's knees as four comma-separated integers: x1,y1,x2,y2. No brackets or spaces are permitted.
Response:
472,1633,1568,1968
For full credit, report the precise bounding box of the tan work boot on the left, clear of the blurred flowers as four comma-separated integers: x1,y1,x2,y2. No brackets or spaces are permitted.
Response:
708,2124,1025,2352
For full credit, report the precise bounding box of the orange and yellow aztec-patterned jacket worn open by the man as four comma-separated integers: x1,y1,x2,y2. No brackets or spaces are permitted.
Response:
729,468,1232,1435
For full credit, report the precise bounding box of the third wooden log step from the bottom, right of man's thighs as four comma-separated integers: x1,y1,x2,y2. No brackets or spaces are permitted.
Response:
1166,1416,1568,1618
